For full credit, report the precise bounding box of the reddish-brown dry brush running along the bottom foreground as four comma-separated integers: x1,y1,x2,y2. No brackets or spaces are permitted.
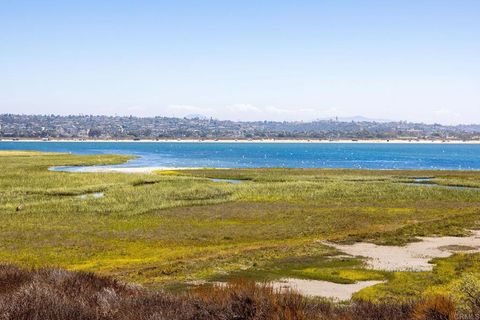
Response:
0,265,478,320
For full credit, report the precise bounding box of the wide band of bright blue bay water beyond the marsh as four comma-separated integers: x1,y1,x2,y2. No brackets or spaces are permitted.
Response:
0,141,480,170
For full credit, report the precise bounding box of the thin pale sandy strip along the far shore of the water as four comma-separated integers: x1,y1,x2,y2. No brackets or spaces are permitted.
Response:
0,138,480,144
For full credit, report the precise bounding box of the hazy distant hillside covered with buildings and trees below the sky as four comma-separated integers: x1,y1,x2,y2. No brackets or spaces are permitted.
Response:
0,114,480,140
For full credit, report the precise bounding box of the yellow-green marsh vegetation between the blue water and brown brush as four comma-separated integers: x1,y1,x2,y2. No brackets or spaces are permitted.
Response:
0,151,480,299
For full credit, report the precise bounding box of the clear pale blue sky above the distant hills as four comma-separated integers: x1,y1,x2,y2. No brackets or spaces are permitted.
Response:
0,0,480,124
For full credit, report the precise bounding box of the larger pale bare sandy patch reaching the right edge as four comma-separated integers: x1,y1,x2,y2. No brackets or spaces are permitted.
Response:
326,230,480,271
